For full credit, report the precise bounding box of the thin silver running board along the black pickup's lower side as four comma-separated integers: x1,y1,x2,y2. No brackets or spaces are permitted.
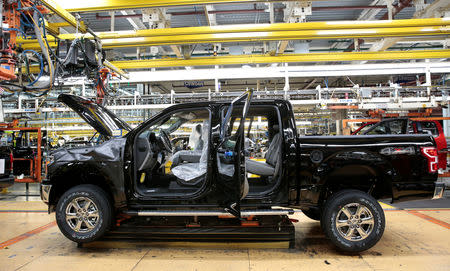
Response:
125,209,294,217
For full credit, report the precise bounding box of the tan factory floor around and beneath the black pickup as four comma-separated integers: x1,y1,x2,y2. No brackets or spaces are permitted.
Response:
0,186,450,271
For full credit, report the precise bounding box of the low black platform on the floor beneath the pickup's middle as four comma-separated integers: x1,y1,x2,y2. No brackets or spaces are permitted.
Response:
80,215,295,248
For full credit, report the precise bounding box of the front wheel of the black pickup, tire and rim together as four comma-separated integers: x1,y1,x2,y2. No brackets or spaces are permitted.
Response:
56,184,112,243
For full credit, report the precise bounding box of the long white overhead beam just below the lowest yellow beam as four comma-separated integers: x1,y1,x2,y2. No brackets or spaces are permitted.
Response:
117,61,450,84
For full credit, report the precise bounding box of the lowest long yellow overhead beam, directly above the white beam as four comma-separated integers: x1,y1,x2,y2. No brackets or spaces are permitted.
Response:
111,49,450,69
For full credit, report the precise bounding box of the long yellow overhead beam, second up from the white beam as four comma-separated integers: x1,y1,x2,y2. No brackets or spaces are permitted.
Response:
19,18,450,43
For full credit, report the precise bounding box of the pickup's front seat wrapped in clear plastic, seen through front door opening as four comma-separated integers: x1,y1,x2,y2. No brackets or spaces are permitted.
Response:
172,119,209,185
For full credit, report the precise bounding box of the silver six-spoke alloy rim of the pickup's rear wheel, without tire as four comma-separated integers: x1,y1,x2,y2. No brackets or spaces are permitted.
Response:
336,203,375,241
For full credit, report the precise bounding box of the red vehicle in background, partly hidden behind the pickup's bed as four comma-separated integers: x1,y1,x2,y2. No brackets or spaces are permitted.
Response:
352,118,448,170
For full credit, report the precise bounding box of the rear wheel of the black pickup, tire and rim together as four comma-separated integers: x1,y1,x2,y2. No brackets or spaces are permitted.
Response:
321,189,385,252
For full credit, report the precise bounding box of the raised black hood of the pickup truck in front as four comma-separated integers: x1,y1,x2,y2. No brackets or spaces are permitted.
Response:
58,94,131,136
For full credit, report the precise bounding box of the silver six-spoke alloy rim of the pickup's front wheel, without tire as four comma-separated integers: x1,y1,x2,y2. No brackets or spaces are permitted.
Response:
66,197,99,233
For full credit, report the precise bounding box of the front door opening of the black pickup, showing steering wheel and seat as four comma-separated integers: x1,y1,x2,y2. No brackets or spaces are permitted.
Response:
135,108,210,199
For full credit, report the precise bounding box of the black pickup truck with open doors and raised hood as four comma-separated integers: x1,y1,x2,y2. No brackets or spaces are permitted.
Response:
41,91,443,252
